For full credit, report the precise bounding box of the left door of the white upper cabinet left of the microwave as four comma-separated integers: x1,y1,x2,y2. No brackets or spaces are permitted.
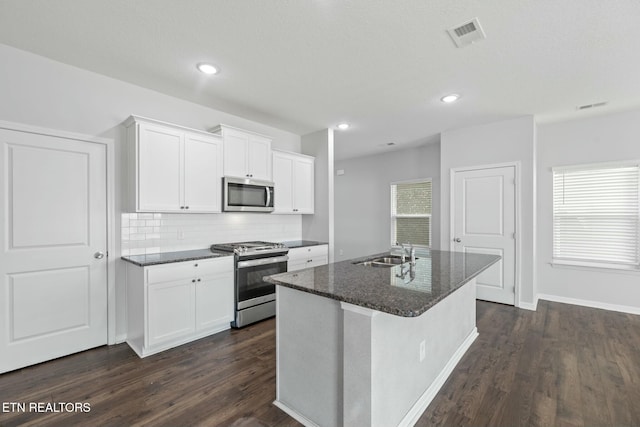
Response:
136,123,183,212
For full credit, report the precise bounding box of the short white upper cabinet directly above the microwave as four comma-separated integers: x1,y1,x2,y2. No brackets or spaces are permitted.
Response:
211,125,272,181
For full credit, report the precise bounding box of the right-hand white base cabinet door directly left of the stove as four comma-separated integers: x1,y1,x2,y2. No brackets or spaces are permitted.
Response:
196,269,234,331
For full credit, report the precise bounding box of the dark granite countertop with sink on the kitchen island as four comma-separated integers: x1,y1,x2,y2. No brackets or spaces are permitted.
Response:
265,250,500,317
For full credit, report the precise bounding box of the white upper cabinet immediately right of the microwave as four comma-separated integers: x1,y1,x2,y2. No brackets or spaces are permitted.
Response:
273,150,315,214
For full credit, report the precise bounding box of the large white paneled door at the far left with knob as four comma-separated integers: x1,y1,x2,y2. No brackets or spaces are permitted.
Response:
0,129,107,372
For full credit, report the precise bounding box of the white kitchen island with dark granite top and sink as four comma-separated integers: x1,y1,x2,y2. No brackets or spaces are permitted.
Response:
266,250,500,427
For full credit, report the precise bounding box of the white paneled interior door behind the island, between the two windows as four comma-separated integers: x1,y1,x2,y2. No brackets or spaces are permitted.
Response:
451,166,516,305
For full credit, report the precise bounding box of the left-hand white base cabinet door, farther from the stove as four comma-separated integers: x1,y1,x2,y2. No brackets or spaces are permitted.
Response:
145,280,195,347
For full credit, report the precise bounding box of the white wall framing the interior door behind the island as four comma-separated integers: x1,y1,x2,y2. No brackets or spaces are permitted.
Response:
440,116,537,308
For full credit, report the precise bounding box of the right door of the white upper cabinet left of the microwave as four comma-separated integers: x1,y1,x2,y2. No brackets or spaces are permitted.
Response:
184,134,222,212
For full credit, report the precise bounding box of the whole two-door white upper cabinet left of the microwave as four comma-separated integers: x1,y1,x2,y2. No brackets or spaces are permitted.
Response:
125,116,223,212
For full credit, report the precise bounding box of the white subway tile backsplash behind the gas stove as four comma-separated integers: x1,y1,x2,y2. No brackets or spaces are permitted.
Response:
121,213,302,256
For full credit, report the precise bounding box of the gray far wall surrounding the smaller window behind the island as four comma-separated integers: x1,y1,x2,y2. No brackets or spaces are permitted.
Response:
335,143,440,261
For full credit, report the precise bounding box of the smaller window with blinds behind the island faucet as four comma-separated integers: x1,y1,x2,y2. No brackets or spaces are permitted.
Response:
391,179,431,247
